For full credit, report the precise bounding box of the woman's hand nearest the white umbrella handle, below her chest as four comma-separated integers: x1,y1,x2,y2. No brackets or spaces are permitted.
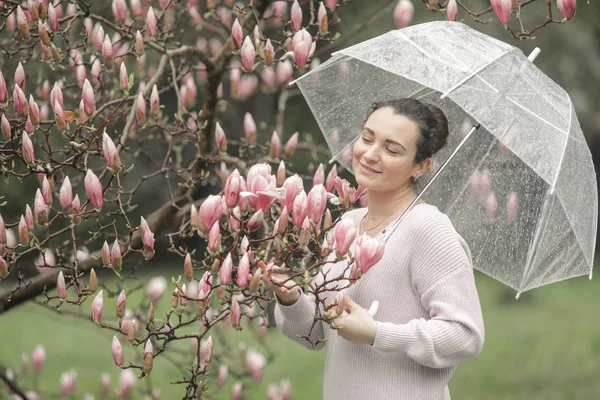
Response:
330,293,377,346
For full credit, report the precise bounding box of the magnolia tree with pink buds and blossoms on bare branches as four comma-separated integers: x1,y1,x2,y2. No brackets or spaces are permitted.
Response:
0,0,575,399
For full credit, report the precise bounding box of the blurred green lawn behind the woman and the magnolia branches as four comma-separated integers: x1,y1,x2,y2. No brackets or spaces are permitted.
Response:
0,266,600,400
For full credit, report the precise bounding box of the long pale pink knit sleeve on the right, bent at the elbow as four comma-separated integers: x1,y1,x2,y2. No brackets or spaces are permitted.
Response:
373,212,484,368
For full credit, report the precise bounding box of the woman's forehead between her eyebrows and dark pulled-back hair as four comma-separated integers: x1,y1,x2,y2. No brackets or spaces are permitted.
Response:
365,107,419,144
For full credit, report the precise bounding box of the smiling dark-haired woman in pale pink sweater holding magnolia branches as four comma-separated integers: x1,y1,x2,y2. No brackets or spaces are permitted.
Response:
270,99,484,400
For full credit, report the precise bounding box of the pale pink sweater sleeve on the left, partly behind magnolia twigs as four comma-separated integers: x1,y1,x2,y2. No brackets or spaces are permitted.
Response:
275,292,325,350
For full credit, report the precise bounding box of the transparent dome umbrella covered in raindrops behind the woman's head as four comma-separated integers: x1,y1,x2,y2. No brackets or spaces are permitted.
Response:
293,22,598,297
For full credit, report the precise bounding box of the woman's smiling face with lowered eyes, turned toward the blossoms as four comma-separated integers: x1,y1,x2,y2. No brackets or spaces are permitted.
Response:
352,107,428,192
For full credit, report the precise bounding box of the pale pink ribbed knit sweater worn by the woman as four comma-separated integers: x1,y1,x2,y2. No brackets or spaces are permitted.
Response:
275,204,484,400
